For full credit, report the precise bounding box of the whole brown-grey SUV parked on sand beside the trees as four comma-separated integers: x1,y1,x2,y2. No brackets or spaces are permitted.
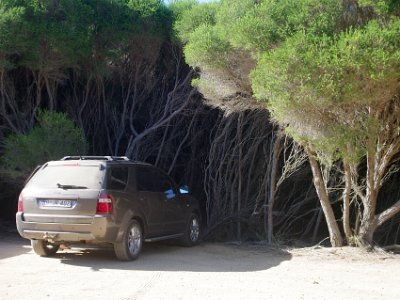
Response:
16,156,200,260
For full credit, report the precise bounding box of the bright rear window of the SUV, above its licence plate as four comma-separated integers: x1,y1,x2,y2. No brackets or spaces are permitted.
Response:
27,164,105,189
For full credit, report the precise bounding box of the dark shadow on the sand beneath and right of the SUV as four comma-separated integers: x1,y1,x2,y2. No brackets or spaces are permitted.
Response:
54,243,291,272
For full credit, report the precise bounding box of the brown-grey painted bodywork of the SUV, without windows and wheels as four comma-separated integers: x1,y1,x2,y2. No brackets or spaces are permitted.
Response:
16,160,199,243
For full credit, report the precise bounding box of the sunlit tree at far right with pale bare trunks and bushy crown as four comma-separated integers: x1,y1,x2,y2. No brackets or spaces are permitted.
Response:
253,20,400,246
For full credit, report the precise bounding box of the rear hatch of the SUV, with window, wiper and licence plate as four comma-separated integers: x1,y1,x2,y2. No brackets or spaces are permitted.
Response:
21,161,106,224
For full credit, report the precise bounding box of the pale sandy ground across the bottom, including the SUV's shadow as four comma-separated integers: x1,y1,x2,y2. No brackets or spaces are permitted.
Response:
0,225,400,300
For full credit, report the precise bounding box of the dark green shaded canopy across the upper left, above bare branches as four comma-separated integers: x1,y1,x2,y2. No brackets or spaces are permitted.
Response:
0,0,172,76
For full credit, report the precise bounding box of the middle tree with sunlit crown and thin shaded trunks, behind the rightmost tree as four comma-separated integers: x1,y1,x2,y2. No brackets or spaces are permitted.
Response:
174,0,324,242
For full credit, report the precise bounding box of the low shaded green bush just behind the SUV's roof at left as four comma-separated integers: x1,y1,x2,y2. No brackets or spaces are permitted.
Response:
1,111,87,175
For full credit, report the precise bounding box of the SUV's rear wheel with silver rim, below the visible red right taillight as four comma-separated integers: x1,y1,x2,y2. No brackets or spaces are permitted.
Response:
114,220,143,261
